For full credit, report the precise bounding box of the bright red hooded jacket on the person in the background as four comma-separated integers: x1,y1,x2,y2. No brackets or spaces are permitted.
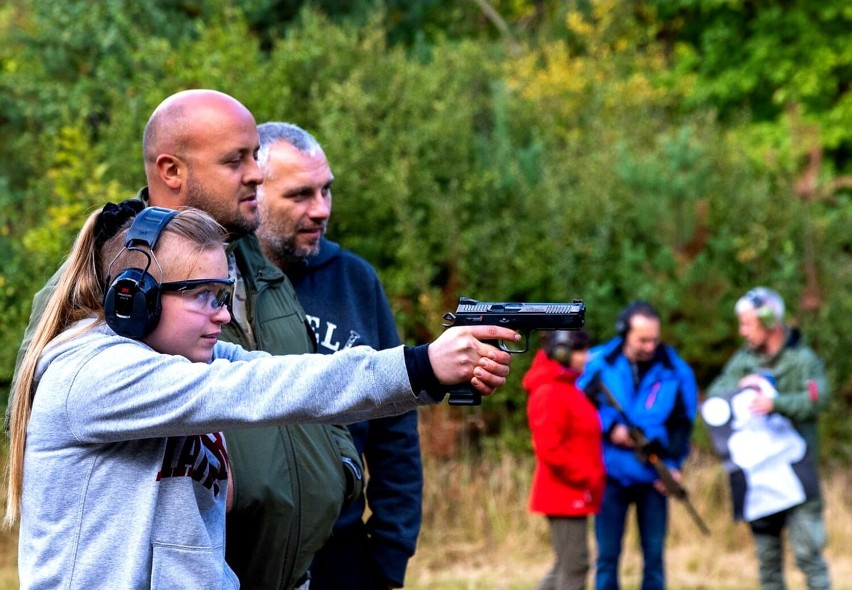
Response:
523,351,605,516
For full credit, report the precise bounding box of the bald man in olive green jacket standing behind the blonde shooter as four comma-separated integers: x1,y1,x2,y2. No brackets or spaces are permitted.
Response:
139,90,362,588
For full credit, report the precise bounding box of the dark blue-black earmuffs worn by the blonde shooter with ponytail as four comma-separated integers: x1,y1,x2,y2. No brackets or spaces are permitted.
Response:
104,207,177,340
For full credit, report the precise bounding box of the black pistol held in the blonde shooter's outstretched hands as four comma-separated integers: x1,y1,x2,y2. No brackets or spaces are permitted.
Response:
443,297,586,406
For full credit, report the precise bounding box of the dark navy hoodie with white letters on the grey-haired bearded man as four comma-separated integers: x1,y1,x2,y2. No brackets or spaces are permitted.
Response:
287,238,423,583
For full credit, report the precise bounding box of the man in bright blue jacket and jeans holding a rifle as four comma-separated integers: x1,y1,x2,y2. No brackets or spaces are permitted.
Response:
577,301,698,590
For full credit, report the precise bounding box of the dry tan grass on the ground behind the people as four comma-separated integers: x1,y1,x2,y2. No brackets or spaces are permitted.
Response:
0,444,852,590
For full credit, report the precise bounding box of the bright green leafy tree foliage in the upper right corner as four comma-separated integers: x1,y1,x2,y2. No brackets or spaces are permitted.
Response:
651,0,852,173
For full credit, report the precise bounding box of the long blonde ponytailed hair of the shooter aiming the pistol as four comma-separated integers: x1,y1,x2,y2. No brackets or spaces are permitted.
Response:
4,207,227,527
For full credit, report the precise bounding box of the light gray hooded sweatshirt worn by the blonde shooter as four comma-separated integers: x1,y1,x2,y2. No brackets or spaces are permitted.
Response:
18,321,435,590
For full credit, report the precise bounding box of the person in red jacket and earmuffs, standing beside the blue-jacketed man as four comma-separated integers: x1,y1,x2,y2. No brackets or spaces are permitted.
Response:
523,330,605,590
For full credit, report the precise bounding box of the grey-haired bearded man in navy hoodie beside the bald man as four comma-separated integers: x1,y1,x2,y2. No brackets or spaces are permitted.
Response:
257,122,423,590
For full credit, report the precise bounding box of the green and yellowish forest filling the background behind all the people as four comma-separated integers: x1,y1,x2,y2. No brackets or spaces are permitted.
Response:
0,0,852,588
